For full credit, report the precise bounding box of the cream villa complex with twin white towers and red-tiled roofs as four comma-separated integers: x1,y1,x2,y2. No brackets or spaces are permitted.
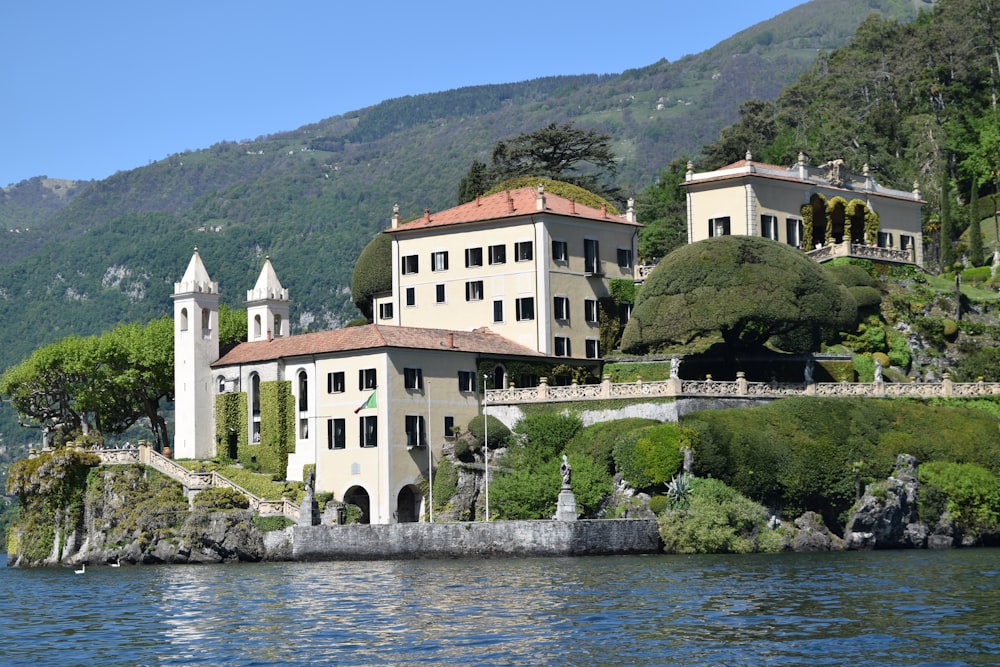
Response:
172,187,641,523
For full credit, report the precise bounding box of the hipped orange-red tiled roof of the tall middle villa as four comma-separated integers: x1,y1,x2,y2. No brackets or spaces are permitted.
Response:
386,188,642,233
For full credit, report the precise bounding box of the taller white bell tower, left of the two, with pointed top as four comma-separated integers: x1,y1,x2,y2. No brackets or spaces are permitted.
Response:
170,248,219,459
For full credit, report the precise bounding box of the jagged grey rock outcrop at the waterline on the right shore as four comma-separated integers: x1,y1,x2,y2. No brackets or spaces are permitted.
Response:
844,454,929,549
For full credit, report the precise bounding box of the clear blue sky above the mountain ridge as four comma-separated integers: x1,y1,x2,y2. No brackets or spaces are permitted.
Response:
0,0,804,187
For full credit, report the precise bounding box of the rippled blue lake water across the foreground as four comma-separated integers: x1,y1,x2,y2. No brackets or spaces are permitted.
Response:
0,549,1000,667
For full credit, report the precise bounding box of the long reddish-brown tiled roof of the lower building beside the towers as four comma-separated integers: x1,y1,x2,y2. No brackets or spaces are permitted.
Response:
212,324,544,366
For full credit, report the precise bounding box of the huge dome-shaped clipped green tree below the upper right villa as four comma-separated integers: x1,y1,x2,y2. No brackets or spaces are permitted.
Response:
622,236,857,354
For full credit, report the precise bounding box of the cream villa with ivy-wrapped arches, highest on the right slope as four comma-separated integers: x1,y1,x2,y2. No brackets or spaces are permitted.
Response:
684,152,924,266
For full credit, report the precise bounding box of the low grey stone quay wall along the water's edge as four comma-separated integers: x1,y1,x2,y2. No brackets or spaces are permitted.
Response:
288,519,662,561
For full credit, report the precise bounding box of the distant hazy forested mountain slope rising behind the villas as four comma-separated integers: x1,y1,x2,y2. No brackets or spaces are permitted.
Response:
0,0,930,462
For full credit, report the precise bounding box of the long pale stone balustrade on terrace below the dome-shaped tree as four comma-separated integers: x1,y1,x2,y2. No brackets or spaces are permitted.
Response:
486,372,1000,405
